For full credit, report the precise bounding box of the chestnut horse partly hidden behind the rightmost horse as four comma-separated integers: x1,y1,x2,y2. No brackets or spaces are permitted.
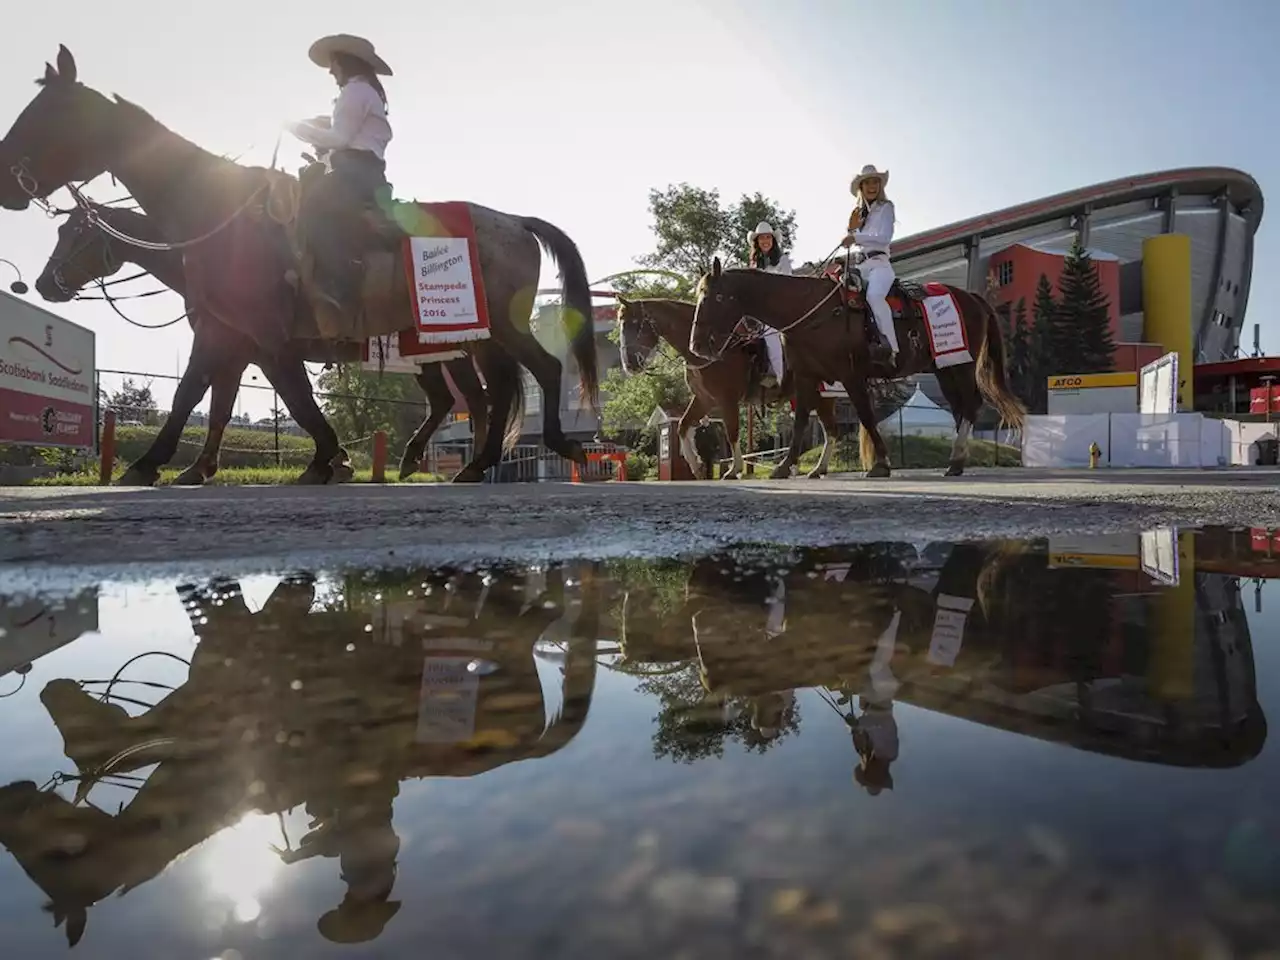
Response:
618,297,838,480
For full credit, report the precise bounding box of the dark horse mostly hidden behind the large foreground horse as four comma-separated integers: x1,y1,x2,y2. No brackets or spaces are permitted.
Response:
36,204,522,486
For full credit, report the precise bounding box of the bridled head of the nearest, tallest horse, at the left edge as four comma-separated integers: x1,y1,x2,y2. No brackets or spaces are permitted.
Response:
0,46,118,210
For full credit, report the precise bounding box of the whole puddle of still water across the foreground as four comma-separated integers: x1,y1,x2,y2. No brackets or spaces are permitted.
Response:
0,529,1280,960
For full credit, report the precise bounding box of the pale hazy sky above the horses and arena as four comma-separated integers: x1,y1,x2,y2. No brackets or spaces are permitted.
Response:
0,0,1280,417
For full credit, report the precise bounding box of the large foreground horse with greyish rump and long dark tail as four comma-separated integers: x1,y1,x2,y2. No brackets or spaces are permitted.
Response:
0,46,599,481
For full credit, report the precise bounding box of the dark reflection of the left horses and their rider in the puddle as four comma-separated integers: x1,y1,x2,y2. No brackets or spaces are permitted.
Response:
0,571,598,943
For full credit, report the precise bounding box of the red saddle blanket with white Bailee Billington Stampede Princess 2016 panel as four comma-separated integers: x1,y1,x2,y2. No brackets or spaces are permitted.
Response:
402,201,489,356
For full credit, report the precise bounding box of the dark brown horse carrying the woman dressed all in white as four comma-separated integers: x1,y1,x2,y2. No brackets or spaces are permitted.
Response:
689,257,1027,477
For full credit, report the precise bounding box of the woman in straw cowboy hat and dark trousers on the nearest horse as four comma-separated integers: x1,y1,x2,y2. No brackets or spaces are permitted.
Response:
285,33,392,320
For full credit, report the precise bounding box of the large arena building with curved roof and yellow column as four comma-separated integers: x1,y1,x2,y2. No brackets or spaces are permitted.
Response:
893,166,1280,412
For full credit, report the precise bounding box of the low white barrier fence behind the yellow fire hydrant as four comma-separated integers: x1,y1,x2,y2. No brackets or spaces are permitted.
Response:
1023,413,1280,467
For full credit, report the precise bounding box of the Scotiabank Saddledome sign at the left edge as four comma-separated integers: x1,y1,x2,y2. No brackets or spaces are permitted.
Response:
0,292,95,448
